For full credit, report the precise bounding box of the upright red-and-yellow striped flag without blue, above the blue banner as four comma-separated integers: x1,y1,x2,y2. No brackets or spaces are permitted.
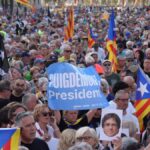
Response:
64,7,74,41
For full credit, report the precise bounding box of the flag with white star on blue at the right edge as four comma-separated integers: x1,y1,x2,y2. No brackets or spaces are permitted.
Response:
135,67,150,131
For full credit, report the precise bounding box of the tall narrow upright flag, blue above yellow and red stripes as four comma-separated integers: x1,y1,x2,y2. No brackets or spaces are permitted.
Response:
106,11,117,72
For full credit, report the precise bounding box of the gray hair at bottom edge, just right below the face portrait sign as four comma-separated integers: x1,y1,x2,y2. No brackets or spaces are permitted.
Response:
121,137,138,150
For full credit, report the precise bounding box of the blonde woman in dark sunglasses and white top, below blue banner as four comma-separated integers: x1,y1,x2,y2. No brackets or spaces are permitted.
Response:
33,104,60,142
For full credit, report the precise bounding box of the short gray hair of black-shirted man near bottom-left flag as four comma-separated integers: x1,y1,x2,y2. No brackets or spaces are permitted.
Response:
15,111,33,127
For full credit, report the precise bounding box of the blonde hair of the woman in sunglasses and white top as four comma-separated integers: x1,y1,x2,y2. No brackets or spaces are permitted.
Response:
33,104,49,121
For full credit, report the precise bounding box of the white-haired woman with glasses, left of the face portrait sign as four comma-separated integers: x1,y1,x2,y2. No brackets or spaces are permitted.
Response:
75,127,101,150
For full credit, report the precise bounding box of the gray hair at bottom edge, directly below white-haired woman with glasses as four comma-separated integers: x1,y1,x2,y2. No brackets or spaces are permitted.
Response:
68,142,92,150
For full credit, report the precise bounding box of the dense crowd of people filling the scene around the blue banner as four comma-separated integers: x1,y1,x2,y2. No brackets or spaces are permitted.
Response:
0,4,150,150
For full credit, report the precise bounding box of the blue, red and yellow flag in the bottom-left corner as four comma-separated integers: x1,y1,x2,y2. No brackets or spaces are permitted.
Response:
0,128,20,150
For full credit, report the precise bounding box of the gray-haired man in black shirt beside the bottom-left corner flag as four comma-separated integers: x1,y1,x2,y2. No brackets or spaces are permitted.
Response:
15,112,49,150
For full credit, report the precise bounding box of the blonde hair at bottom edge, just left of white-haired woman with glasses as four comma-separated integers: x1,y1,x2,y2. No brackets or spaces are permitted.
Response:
58,129,76,150
